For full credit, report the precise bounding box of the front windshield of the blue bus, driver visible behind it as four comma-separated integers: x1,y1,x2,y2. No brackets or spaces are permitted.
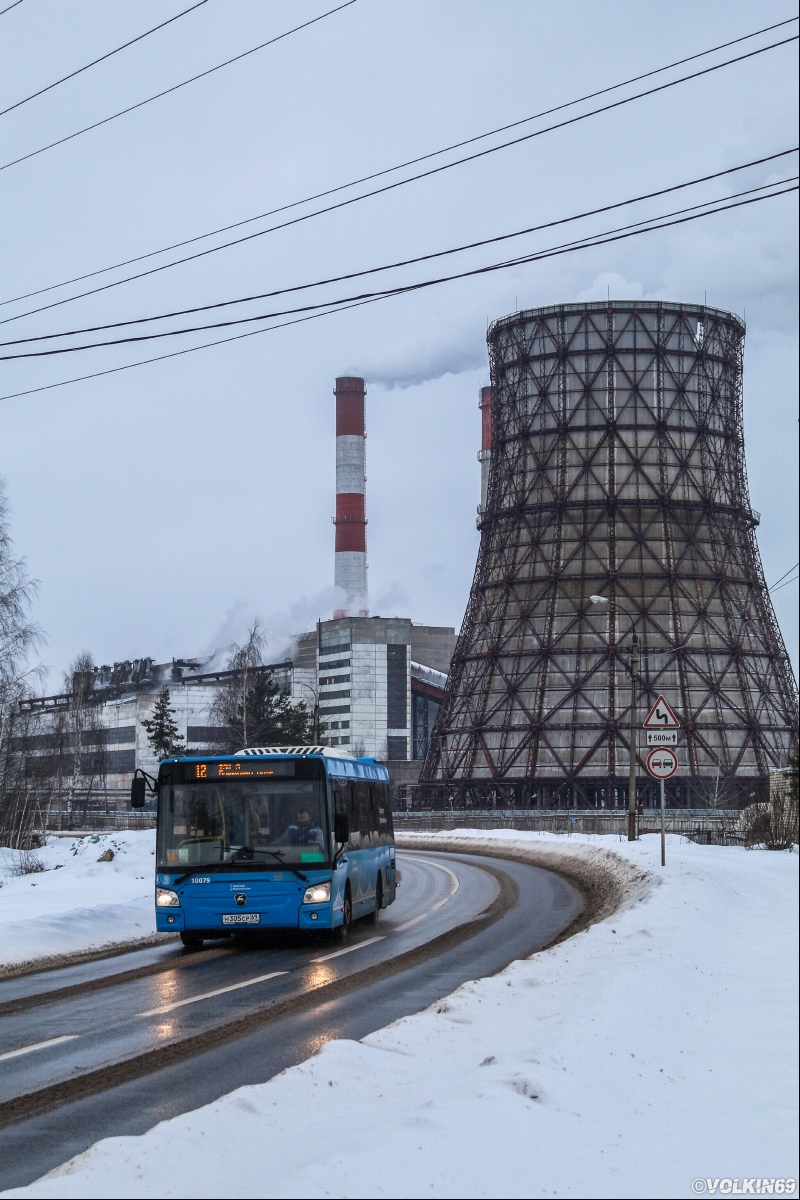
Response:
158,779,331,871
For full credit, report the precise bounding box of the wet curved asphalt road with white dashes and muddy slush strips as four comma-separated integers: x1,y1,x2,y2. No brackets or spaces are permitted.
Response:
0,851,582,1189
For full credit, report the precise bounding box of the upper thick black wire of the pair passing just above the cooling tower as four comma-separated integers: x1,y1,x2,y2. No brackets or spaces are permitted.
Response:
0,146,800,348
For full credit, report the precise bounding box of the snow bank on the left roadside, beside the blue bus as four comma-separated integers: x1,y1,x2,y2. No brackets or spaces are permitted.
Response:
0,829,156,976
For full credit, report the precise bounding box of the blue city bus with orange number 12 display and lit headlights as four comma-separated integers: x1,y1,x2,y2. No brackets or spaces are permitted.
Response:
131,746,397,948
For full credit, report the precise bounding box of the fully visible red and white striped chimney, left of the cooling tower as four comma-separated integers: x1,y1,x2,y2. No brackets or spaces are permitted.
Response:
333,376,369,617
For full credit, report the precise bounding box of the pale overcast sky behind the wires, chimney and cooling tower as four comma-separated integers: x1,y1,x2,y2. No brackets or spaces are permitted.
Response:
0,0,798,682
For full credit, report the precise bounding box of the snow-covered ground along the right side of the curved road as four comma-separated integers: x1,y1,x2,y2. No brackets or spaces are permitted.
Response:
2,830,798,1198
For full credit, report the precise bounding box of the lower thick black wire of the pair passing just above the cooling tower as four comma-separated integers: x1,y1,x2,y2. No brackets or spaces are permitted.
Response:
0,184,798,362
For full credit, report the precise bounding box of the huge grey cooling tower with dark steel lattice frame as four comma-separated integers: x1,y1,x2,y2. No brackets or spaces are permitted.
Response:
416,301,798,808
